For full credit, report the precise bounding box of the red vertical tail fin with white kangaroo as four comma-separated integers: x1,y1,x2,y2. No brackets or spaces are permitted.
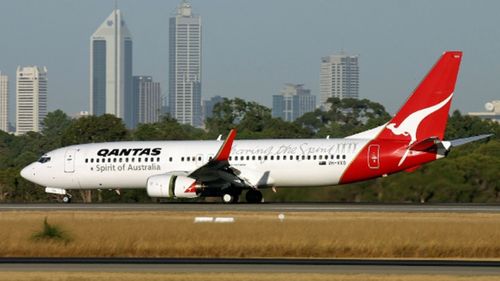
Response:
378,51,462,145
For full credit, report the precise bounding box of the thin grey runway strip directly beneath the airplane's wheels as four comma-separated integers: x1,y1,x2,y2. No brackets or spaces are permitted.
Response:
0,202,500,213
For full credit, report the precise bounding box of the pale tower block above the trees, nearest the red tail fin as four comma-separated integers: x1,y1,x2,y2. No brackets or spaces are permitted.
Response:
319,54,359,106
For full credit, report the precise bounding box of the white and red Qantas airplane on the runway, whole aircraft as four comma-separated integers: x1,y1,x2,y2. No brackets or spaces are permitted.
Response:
21,51,490,203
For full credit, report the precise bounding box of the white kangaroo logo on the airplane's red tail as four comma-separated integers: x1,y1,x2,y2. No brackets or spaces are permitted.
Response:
386,93,453,166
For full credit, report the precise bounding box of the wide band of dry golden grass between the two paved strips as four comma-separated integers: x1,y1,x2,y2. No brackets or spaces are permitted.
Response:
0,204,500,260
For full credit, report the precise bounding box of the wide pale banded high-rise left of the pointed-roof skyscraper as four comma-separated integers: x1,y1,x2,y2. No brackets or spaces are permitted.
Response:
16,66,47,135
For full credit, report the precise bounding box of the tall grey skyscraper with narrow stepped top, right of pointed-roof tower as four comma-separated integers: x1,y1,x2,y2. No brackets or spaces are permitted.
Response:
168,1,202,127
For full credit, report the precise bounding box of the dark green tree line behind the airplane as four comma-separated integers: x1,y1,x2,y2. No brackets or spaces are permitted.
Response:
0,98,500,202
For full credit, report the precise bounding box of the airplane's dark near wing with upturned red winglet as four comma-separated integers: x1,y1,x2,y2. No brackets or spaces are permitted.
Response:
188,129,243,184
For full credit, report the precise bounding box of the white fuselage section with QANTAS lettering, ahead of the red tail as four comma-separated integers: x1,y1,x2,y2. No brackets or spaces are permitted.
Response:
21,139,369,189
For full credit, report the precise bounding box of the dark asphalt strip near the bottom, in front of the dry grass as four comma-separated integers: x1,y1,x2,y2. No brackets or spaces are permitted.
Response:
0,258,500,276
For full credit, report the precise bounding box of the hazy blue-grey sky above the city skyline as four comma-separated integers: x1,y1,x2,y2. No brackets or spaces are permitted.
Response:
0,0,500,120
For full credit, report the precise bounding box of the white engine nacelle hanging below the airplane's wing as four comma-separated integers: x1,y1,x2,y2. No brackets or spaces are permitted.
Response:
146,174,201,198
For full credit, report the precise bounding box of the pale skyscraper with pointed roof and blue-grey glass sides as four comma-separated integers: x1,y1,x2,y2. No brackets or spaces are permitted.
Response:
90,9,133,128
